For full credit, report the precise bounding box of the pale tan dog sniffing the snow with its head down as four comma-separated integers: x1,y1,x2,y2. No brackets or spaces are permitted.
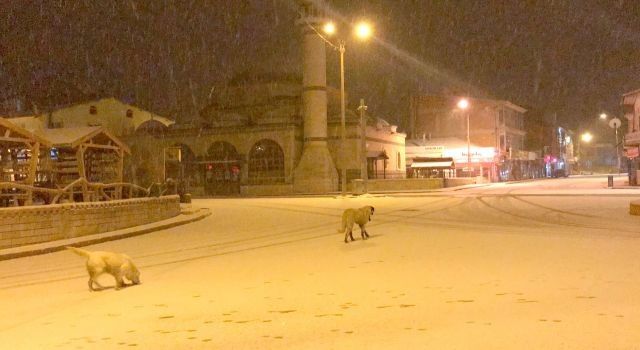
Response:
67,247,140,291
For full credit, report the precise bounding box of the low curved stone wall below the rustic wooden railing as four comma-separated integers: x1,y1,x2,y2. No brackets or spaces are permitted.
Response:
0,196,180,249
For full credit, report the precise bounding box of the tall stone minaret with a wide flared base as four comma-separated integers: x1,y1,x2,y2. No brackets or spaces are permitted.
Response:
293,0,338,193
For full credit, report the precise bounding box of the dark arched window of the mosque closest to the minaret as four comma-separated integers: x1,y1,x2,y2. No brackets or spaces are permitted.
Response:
249,139,285,184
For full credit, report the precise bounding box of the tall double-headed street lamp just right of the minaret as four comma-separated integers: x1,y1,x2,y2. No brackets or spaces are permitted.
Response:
320,22,373,196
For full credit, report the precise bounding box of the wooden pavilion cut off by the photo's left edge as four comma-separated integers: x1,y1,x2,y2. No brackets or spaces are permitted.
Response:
0,118,51,206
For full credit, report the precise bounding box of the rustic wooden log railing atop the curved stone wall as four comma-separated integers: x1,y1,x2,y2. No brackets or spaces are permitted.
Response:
0,178,151,206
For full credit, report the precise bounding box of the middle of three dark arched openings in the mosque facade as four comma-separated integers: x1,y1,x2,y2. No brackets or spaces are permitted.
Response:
203,141,241,195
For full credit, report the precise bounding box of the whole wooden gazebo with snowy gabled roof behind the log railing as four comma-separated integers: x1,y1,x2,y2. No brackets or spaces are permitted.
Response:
40,127,131,201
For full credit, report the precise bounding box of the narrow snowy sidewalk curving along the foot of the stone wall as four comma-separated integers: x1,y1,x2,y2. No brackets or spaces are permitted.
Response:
0,206,211,261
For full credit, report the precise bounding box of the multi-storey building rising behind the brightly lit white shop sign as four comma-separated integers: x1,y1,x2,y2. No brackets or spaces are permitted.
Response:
407,95,535,181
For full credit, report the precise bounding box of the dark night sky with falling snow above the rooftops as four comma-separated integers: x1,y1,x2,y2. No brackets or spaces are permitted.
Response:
0,0,640,132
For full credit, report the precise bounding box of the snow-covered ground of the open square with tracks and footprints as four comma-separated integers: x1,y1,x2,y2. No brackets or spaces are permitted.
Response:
0,177,640,349
